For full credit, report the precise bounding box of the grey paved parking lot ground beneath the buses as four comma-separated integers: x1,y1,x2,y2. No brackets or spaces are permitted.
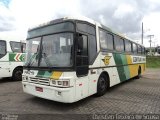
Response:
0,69,160,118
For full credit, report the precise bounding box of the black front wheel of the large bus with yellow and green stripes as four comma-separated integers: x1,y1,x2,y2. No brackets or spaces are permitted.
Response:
96,74,109,97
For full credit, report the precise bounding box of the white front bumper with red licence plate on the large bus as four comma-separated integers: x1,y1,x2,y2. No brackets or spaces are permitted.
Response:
22,81,75,103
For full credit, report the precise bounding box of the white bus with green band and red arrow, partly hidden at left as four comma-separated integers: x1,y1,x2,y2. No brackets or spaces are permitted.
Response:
0,40,26,80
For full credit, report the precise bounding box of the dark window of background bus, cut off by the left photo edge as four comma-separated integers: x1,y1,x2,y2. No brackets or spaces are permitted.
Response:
0,40,7,58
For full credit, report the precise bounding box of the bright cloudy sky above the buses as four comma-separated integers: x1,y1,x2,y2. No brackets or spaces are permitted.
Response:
0,0,160,46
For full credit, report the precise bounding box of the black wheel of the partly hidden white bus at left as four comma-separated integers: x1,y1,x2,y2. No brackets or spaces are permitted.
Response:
12,67,23,81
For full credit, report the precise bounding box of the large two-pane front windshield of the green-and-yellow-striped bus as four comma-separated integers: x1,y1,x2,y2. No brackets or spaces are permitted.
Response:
26,32,73,67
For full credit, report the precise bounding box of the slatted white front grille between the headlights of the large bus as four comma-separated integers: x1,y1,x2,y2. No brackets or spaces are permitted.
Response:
29,77,49,85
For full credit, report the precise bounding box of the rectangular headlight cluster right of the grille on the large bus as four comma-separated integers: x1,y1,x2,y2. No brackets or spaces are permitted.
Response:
50,79,70,87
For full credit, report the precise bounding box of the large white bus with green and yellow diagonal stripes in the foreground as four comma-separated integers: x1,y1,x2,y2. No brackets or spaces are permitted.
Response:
22,17,146,103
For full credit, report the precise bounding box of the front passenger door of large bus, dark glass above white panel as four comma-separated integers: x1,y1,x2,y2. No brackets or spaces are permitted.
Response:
76,34,88,100
